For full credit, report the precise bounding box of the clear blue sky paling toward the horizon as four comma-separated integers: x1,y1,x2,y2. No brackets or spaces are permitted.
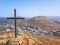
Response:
0,0,60,17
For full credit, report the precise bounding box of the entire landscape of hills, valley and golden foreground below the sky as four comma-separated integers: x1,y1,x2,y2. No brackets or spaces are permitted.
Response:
0,16,60,45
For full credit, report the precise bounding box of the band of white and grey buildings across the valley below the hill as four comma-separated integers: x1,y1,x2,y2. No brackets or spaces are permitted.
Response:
0,24,60,36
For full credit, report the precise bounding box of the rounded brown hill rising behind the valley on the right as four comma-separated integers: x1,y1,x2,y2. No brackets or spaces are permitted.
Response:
23,16,60,31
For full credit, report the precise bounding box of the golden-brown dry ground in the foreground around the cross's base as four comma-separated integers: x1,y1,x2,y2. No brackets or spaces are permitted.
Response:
0,32,60,45
